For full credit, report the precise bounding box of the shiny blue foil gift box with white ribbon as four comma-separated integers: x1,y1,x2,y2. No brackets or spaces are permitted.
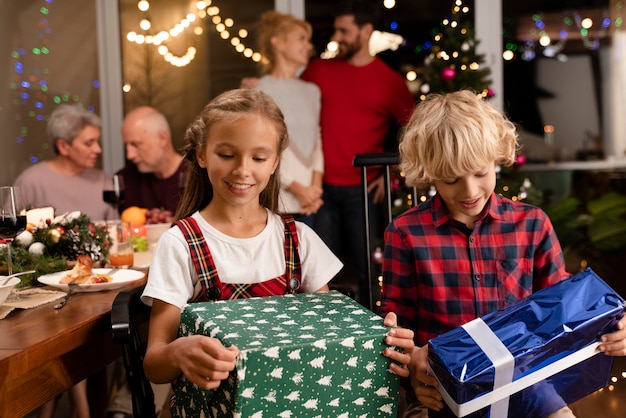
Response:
428,269,625,418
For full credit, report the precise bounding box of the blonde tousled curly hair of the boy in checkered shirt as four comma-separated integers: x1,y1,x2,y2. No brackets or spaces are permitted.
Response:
400,90,519,187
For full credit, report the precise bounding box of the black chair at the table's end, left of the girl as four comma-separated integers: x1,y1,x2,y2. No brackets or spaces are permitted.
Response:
111,286,156,418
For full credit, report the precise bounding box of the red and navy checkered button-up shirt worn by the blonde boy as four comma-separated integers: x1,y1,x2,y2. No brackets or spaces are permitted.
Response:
380,193,569,345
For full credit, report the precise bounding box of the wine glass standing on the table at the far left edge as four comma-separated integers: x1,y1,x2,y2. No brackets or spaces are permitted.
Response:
0,186,26,275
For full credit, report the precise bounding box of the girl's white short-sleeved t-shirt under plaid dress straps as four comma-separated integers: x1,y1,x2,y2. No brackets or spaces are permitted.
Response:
141,210,343,310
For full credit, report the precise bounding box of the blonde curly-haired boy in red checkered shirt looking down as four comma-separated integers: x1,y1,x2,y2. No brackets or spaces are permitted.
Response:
381,91,626,418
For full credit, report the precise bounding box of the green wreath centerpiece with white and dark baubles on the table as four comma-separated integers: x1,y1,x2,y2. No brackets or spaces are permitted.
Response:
0,211,111,288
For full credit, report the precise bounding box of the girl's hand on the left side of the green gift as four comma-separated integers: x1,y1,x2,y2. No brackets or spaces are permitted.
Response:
173,335,239,389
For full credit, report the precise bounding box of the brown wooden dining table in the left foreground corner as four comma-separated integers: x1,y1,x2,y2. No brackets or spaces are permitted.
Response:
0,278,145,418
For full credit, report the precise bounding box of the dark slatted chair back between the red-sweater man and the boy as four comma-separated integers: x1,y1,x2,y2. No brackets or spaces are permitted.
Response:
352,152,417,311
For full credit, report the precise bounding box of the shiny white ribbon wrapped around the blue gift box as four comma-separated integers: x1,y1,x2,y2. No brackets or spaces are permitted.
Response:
430,318,600,418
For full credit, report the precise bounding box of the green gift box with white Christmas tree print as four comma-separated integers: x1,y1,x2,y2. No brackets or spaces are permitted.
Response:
175,291,399,418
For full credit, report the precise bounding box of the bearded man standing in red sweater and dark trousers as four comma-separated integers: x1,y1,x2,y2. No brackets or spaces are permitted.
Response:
301,0,415,303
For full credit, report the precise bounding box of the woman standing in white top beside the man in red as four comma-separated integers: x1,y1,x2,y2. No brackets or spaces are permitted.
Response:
258,11,324,226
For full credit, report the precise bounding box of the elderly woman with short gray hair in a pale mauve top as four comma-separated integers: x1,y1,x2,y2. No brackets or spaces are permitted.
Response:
14,105,118,220
